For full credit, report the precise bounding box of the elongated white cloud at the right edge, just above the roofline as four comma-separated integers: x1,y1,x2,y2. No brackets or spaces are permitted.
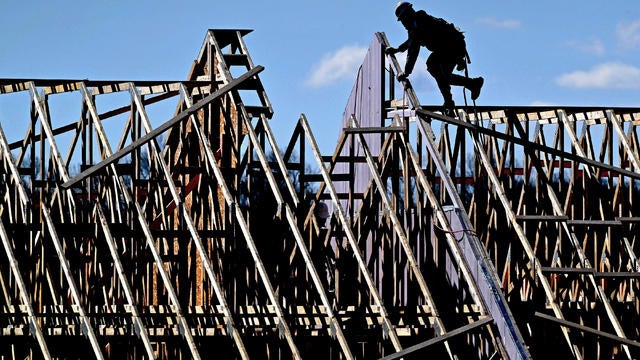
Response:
556,63,640,89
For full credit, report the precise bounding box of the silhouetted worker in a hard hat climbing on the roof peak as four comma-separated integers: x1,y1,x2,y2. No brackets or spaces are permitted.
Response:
385,1,484,116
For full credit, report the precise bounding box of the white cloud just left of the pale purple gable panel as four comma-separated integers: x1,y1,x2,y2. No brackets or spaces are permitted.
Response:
306,45,367,88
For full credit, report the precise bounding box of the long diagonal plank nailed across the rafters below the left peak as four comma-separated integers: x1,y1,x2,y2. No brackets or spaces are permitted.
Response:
62,65,264,189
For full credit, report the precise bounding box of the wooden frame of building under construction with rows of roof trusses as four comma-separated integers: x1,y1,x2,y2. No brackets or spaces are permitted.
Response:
0,30,640,359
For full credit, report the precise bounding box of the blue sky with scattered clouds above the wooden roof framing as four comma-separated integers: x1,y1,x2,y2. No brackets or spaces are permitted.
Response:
0,0,640,153
